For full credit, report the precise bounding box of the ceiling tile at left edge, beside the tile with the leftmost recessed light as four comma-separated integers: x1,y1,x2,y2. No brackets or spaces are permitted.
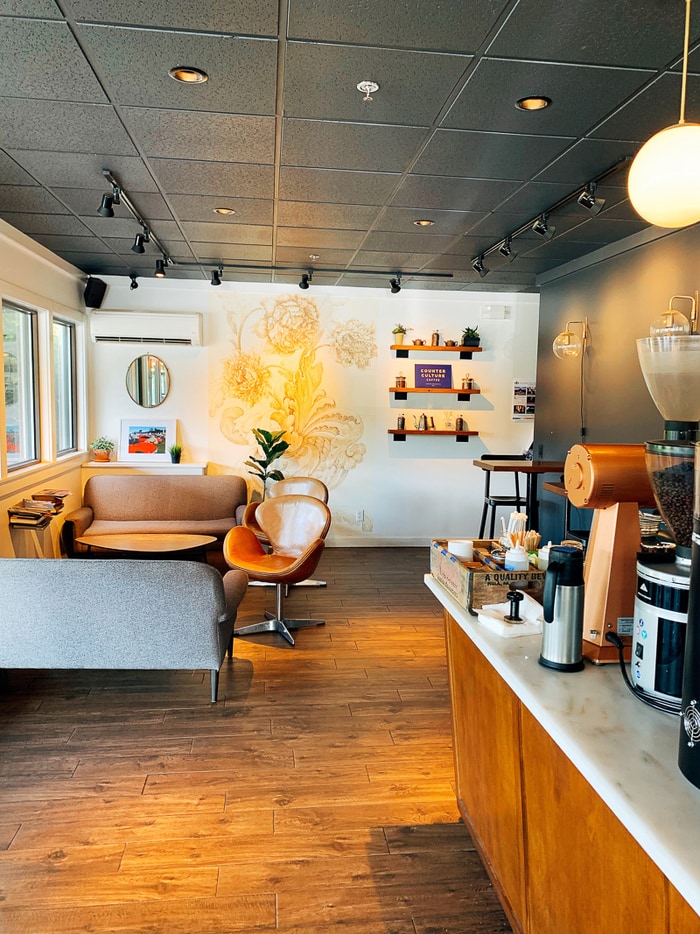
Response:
0,19,107,103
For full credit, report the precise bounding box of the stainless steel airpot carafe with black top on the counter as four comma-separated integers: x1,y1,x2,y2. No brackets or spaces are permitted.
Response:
539,545,583,671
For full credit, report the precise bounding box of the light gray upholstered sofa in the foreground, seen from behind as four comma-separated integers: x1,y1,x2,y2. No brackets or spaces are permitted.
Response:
0,558,248,703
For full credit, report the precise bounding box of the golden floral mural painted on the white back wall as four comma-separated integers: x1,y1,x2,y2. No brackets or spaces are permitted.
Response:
209,293,377,498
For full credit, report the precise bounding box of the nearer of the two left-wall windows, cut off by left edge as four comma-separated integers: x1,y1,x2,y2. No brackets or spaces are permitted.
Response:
2,305,40,470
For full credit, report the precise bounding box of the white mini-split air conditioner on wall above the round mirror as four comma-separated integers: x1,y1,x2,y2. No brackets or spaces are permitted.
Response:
90,311,202,347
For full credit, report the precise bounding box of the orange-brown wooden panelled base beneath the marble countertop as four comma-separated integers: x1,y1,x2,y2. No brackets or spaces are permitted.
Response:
445,611,700,934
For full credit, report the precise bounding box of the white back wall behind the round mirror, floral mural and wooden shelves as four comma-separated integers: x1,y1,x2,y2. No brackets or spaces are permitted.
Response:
94,277,539,546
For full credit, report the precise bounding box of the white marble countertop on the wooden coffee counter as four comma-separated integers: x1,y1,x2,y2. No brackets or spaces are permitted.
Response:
425,574,700,914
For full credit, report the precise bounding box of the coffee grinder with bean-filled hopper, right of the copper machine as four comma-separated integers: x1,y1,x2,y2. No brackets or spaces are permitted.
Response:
631,334,700,716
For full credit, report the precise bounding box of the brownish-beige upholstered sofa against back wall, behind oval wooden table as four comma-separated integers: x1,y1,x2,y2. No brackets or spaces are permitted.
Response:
62,474,247,570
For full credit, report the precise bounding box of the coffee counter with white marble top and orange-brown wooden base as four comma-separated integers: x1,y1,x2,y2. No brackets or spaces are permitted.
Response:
425,574,700,934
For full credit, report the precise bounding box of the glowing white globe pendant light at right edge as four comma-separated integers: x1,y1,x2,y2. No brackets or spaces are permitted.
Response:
627,123,700,227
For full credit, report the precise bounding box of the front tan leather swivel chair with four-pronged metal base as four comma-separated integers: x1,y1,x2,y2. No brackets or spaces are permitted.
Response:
223,494,331,645
